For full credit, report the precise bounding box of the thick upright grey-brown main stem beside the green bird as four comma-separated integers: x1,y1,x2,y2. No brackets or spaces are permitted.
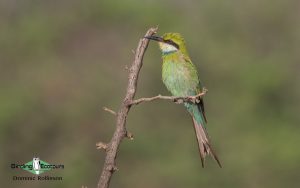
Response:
97,28,158,188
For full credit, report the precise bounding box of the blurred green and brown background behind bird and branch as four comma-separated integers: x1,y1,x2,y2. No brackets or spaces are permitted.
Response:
0,0,300,188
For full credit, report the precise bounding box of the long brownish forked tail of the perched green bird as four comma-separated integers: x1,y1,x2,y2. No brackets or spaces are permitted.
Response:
192,116,222,168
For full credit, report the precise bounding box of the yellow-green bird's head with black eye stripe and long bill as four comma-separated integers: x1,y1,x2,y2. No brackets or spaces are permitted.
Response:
145,33,188,55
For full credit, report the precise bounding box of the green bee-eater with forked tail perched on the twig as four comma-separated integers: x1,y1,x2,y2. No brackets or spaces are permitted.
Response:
144,33,222,168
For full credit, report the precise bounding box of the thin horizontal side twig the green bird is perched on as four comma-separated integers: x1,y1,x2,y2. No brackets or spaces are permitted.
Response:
128,88,207,105
